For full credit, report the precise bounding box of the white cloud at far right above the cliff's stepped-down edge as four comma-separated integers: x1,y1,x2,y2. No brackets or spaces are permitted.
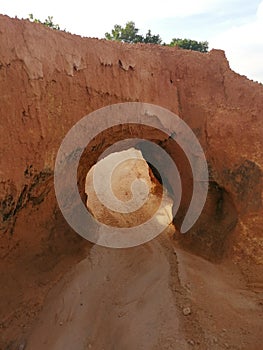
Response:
210,1,263,83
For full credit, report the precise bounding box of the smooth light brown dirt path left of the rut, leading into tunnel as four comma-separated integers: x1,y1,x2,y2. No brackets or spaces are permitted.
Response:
27,240,189,350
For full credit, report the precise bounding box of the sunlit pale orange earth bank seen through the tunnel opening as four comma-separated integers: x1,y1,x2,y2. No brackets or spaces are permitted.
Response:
85,149,173,229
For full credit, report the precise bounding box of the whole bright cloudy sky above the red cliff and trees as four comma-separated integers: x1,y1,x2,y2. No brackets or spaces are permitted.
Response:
0,0,263,83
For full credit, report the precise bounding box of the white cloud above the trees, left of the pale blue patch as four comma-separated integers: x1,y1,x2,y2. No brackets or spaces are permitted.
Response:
0,0,243,37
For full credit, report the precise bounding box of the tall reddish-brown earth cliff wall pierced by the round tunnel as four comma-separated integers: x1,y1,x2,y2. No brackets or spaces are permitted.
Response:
0,16,263,347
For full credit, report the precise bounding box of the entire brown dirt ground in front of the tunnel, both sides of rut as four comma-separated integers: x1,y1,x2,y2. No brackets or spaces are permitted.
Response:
26,238,262,350
